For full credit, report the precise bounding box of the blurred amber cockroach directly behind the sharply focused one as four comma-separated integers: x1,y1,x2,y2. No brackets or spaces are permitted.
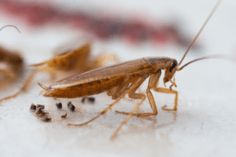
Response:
0,39,118,102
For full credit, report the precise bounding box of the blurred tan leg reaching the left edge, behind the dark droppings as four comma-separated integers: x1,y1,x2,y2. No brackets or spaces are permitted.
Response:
0,70,36,103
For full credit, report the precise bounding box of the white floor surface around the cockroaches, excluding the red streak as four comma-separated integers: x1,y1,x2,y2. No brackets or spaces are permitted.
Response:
0,0,236,157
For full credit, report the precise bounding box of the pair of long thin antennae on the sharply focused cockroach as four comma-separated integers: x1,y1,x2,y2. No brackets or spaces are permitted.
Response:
178,0,223,71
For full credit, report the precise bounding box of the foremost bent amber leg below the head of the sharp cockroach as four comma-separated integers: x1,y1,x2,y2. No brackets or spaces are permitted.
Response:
153,87,179,111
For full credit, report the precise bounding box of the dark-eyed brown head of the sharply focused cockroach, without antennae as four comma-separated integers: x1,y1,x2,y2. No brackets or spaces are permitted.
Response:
163,59,178,83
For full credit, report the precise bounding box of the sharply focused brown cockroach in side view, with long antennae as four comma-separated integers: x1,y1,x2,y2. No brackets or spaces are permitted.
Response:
39,0,222,137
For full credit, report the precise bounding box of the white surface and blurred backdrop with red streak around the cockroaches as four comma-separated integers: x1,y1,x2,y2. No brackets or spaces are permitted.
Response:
0,0,236,157
